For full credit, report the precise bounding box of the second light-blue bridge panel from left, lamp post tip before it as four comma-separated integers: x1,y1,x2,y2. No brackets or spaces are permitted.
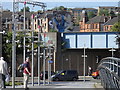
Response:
77,34,91,48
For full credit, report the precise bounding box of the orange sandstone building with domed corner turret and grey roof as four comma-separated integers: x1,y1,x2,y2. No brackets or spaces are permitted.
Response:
79,11,109,32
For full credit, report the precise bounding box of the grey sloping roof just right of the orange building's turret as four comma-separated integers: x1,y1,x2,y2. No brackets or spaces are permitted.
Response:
86,16,109,24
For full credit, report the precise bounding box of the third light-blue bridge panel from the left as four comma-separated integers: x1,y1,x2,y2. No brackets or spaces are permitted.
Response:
92,34,106,48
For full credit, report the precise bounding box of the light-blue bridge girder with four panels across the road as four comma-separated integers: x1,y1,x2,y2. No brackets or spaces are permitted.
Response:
63,32,118,49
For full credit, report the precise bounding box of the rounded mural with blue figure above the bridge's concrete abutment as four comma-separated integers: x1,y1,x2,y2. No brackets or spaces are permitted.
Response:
49,11,73,32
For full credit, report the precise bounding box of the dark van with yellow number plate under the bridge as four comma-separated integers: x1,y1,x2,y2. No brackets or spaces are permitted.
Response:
51,70,78,81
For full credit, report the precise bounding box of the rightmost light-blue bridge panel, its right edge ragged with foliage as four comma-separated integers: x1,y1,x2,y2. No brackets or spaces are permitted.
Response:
108,34,118,48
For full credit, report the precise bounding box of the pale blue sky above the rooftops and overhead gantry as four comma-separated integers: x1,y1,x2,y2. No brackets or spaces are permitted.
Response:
0,0,120,11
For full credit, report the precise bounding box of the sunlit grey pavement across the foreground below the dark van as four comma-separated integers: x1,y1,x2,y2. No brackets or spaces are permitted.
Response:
7,76,104,90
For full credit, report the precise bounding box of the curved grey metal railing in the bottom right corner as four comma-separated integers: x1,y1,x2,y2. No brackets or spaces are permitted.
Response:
97,57,120,90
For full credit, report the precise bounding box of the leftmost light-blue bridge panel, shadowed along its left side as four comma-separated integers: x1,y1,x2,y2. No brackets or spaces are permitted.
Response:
65,34,76,48
